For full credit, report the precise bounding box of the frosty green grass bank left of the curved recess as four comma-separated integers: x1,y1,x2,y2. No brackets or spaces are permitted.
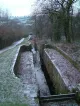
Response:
0,38,28,106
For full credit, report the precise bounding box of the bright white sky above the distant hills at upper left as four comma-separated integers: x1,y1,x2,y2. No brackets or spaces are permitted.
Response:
0,0,36,16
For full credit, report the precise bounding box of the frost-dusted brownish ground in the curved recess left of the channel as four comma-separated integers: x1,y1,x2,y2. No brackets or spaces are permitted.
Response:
18,52,38,106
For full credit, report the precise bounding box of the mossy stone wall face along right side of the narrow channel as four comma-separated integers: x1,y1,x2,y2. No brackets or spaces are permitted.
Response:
43,49,69,94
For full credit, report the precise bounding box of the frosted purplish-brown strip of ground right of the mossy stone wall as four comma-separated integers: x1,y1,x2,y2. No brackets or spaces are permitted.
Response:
45,49,80,90
